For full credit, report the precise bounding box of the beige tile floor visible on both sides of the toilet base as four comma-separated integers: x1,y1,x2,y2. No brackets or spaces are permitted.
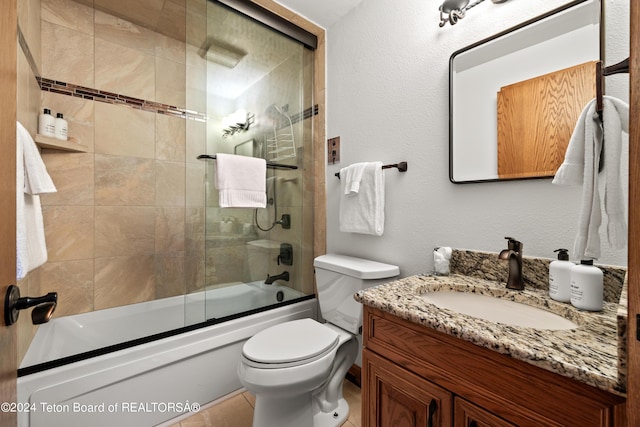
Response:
171,381,362,427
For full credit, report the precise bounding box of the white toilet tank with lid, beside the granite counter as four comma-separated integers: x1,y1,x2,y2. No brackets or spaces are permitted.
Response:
313,254,400,334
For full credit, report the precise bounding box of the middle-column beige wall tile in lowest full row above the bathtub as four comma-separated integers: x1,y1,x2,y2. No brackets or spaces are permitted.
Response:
94,255,155,310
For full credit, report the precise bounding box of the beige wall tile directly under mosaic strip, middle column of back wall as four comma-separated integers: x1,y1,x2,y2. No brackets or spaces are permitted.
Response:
95,102,155,159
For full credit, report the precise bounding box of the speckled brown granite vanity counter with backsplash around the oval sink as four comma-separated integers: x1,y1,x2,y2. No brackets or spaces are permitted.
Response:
355,251,626,396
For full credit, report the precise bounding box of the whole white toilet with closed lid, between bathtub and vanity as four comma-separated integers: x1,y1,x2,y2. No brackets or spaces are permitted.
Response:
238,254,400,427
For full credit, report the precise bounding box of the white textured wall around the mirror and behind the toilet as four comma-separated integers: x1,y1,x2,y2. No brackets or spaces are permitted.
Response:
327,0,629,276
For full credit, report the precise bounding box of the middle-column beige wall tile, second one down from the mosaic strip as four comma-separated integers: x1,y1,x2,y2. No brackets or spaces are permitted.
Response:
95,154,156,206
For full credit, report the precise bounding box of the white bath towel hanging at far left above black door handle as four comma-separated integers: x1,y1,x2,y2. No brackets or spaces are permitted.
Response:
16,123,56,280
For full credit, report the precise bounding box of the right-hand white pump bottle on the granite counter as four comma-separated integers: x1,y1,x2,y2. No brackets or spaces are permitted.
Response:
571,259,604,311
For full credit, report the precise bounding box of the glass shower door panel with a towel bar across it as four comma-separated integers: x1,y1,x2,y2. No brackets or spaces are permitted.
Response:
198,1,313,320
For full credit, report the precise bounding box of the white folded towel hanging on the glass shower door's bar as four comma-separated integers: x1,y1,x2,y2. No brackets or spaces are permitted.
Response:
216,153,267,208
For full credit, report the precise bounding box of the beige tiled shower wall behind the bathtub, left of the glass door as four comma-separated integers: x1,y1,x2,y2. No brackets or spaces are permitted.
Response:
26,0,206,342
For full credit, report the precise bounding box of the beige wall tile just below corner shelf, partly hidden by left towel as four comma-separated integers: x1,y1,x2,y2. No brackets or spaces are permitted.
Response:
40,150,94,206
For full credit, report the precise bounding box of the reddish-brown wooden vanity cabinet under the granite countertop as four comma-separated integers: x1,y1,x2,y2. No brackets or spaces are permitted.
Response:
362,306,626,427
